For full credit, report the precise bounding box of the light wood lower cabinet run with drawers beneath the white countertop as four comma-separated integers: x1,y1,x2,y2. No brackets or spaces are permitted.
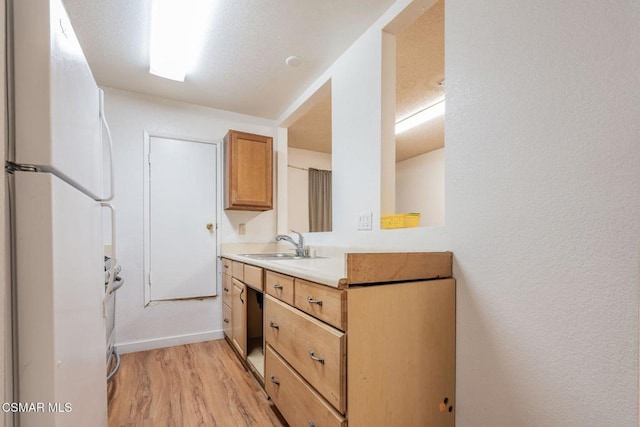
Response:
223,260,456,427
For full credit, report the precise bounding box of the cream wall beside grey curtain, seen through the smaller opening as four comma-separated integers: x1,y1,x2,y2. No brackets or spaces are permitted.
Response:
287,147,331,233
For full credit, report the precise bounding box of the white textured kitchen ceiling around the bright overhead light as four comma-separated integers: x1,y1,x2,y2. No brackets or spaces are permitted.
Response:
63,0,394,119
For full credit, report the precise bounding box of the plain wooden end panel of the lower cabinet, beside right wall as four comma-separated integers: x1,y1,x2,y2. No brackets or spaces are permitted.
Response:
347,279,456,427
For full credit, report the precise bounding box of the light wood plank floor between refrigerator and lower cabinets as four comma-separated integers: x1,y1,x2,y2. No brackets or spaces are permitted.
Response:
108,340,286,427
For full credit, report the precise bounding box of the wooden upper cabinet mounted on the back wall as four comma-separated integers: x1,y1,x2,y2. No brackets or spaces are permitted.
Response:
224,130,273,211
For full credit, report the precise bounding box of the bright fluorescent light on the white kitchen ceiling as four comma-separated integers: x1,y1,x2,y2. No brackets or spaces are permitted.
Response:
149,0,216,82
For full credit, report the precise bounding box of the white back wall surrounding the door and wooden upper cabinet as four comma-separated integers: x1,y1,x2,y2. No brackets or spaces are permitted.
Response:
105,88,277,352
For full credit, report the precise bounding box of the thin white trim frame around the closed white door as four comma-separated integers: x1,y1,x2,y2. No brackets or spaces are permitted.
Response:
142,130,223,307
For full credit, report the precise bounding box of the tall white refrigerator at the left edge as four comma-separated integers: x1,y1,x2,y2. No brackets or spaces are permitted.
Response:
7,0,115,427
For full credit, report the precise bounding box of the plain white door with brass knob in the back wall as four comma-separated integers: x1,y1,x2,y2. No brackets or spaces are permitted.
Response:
147,137,217,301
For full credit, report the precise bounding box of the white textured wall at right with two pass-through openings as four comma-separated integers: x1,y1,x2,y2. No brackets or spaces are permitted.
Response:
282,0,640,427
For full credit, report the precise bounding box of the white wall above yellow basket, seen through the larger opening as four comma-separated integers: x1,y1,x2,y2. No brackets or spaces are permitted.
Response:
395,148,445,227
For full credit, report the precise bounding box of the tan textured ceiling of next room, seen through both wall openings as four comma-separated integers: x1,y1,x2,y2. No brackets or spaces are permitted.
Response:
289,0,444,161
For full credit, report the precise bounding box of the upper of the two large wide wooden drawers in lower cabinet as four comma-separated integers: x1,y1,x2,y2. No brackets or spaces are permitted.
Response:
264,295,346,414
